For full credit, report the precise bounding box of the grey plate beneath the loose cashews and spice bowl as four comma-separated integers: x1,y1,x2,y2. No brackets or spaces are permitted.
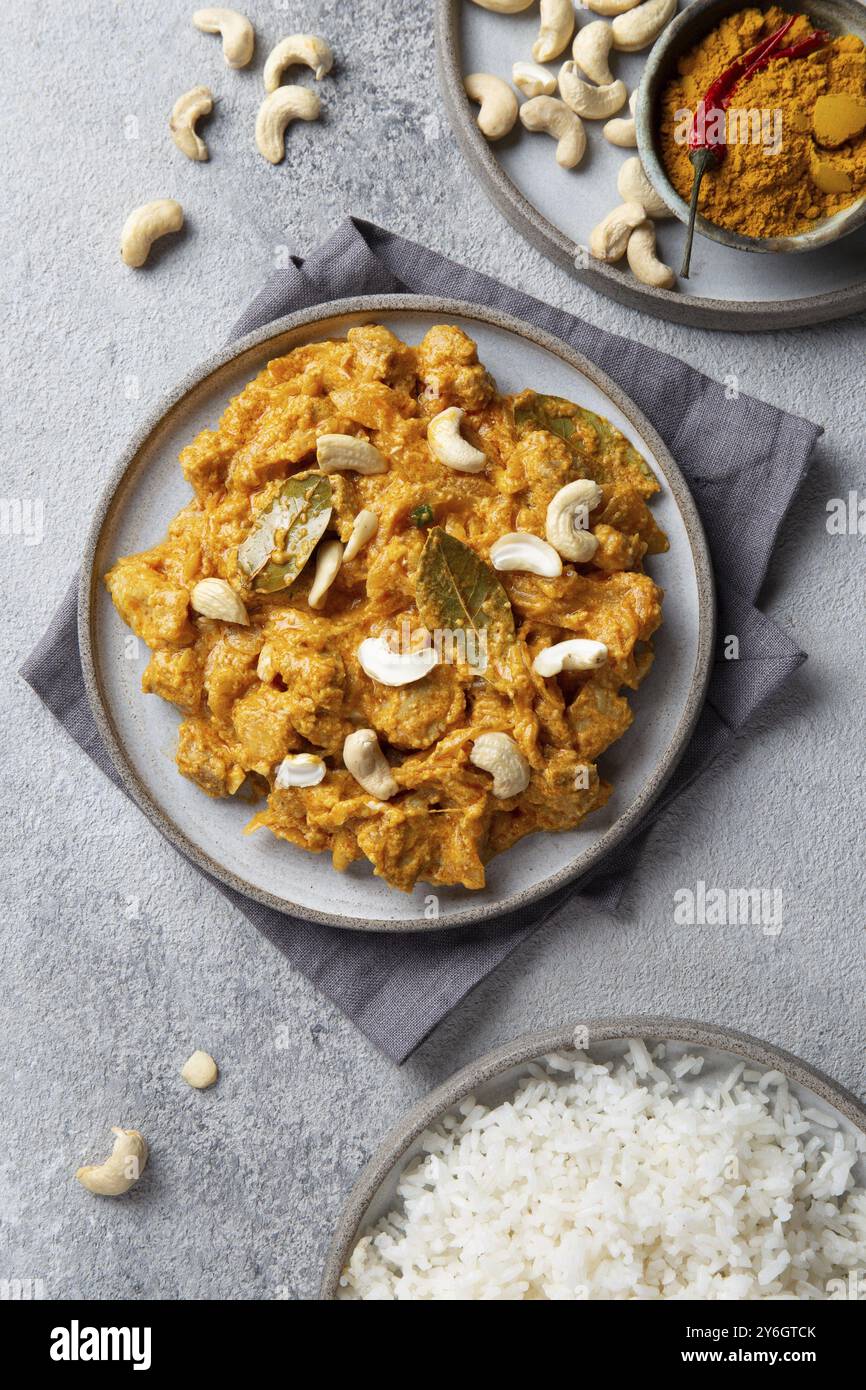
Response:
436,0,866,332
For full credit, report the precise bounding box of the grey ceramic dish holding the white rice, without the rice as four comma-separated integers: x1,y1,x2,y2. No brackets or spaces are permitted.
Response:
320,1015,866,1300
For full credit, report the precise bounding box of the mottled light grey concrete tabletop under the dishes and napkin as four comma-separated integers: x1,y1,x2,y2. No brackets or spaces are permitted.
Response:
0,0,866,1298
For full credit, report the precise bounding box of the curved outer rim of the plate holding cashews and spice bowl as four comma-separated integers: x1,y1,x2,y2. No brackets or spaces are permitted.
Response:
435,0,866,332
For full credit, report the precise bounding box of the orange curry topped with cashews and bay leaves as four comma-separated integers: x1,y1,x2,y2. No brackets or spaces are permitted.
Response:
106,325,667,891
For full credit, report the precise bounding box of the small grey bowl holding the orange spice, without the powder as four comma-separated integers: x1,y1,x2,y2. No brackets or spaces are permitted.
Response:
635,0,866,254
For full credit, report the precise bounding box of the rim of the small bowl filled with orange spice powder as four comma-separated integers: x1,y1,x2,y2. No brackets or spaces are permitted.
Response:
635,0,866,256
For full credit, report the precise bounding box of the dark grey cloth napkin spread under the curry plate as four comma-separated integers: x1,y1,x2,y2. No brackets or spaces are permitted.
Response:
22,218,822,1062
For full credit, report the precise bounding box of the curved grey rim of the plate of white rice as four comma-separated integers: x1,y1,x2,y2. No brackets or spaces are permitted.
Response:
318,1013,866,1302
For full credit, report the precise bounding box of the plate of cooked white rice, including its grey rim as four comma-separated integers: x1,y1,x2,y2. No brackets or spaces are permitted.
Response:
321,1017,866,1301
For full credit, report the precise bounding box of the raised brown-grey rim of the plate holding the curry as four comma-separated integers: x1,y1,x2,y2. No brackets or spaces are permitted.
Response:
78,295,716,934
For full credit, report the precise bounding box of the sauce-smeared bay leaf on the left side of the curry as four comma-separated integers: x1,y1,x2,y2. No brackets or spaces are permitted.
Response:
238,473,332,594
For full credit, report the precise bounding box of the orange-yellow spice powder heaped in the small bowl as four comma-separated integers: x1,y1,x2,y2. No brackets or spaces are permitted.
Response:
662,6,866,236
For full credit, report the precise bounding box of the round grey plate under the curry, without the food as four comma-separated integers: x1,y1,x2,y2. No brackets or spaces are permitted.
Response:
79,296,714,931
